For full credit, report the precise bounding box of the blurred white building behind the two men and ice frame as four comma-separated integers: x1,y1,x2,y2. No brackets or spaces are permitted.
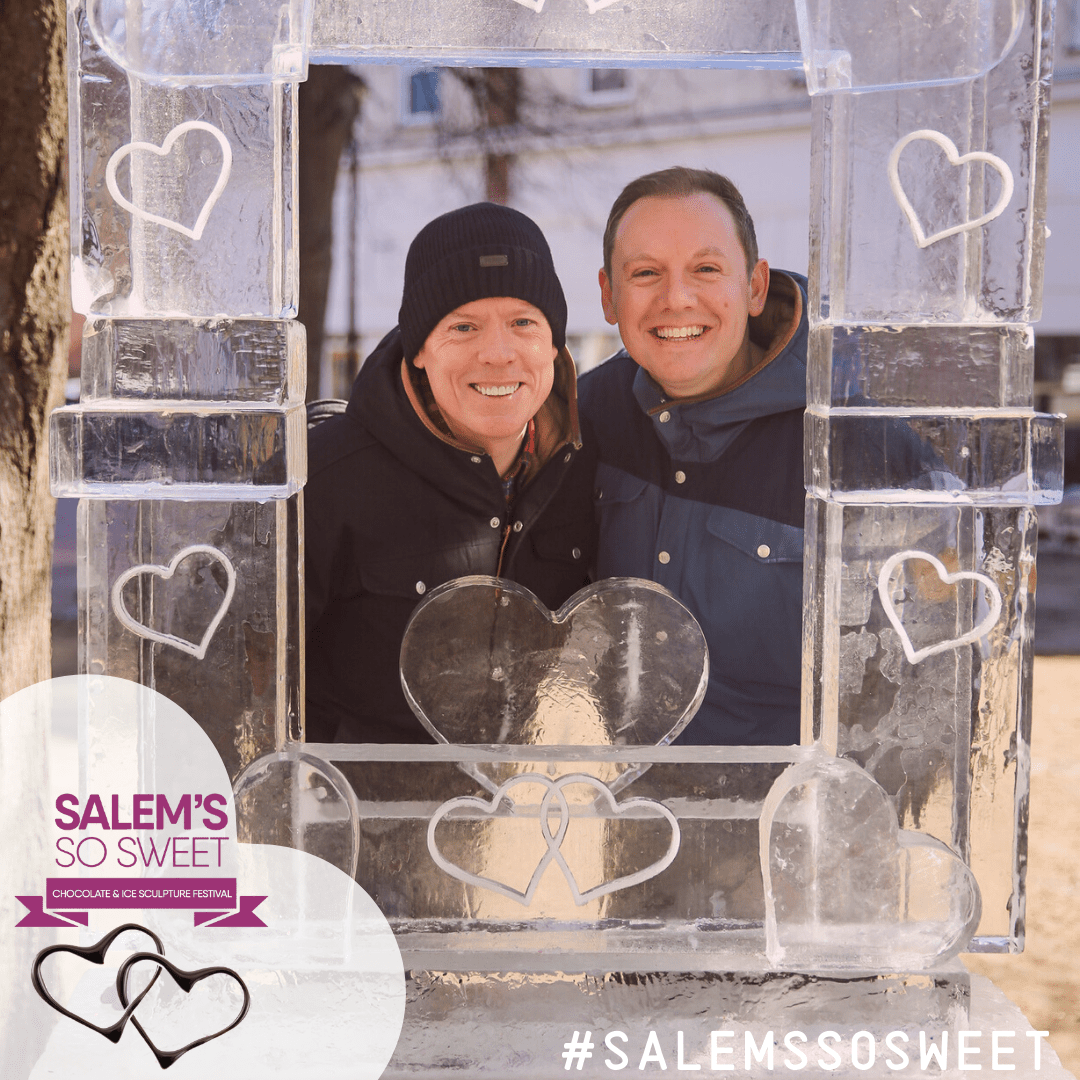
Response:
320,24,1080,425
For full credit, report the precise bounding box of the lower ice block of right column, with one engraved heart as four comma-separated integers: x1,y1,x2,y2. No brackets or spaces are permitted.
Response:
802,498,1037,947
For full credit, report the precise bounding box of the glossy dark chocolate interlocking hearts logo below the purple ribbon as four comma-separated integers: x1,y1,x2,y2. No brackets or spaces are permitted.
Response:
30,922,252,1069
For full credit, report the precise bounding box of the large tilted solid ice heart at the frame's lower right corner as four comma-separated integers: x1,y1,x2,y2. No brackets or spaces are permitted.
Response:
759,755,982,971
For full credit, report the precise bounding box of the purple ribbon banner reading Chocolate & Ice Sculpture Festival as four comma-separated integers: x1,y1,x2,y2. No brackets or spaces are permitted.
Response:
15,877,266,927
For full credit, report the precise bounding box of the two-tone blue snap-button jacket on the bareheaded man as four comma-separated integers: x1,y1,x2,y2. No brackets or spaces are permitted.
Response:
579,271,808,745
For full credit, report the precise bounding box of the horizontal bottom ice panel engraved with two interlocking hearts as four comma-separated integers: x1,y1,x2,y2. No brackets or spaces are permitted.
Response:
328,744,794,933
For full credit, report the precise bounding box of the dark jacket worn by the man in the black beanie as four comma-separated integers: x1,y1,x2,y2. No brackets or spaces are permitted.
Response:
305,330,595,742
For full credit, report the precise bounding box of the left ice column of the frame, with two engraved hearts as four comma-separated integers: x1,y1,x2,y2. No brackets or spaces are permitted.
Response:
51,2,307,777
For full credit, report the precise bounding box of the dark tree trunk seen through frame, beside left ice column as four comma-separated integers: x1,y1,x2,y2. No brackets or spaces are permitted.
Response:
298,64,364,401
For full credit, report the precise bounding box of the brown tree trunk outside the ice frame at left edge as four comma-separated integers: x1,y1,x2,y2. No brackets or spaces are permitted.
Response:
0,0,70,699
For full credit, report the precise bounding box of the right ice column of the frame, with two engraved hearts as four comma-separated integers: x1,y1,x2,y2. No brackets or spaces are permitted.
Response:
798,0,1062,948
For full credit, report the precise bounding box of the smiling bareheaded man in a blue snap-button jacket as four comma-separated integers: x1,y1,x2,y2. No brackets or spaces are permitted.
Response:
580,167,808,745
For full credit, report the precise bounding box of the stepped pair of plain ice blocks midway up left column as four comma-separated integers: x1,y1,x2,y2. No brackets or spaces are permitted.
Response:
50,319,307,501
